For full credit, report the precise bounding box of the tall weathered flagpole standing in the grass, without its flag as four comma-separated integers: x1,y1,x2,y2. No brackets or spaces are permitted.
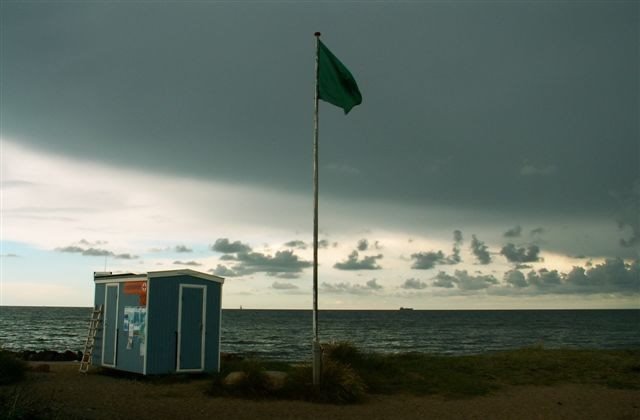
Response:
312,32,322,385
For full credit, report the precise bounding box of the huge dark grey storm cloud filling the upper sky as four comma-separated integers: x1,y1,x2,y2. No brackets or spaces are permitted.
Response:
0,1,640,220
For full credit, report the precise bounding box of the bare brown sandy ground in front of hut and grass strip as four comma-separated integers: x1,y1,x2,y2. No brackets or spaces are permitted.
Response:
21,362,640,420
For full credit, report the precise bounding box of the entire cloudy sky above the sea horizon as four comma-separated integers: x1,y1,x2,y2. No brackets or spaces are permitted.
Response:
0,0,640,309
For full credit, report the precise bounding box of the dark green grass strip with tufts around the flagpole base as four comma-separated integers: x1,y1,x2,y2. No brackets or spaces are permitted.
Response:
213,343,640,403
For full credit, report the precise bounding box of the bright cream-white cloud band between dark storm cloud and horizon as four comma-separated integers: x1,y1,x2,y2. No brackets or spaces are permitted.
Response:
0,141,626,308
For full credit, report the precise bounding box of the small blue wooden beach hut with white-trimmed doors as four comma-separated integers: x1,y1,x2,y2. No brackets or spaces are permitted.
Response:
91,270,224,375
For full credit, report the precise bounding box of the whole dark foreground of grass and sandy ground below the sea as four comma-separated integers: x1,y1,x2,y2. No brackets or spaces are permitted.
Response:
0,344,640,420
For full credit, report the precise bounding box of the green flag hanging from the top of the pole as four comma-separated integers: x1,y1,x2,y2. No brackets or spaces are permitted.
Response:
318,40,362,114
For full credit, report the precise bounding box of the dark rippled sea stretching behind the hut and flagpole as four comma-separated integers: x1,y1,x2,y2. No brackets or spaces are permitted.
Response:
0,306,640,361
